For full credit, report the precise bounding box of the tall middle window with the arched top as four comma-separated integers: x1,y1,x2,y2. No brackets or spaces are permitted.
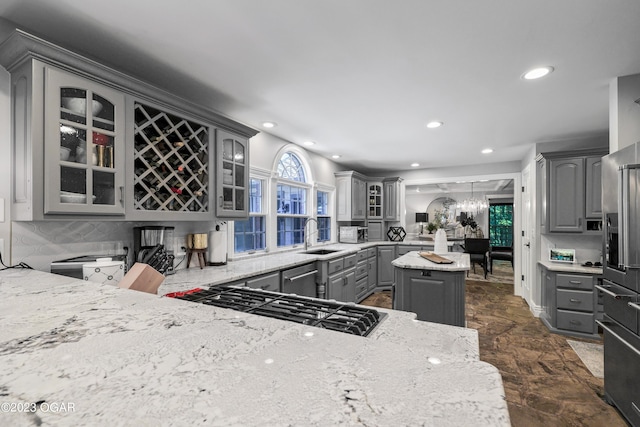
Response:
276,152,309,247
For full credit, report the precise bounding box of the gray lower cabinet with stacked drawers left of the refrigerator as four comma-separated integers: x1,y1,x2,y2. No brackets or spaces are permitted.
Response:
540,267,599,338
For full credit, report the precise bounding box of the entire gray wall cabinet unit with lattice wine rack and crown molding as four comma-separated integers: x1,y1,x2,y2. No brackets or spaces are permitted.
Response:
0,30,257,221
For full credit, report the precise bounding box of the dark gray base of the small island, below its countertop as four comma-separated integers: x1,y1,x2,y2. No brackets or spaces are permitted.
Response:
393,268,465,326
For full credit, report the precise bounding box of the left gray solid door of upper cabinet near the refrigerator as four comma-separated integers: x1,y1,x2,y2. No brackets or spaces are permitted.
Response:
549,158,585,232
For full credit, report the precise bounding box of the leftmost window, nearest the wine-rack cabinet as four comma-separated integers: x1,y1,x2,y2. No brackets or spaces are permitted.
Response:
233,178,267,253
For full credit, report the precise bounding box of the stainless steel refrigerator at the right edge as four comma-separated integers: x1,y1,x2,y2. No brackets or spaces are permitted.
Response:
597,143,640,426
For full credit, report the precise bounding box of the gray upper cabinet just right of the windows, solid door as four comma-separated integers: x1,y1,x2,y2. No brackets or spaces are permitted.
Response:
335,171,367,221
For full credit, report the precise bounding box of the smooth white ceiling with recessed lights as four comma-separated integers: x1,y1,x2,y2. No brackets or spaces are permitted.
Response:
0,0,640,173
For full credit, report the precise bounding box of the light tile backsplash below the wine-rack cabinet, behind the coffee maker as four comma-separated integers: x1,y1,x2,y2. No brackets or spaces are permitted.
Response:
10,221,216,272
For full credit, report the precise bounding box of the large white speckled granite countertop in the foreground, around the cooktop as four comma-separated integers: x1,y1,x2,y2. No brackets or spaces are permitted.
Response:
0,269,510,426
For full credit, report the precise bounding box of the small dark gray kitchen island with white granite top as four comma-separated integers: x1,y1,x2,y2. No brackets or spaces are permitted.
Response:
391,251,470,326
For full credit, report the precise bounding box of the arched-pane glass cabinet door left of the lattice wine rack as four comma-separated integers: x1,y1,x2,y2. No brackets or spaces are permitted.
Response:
44,67,125,215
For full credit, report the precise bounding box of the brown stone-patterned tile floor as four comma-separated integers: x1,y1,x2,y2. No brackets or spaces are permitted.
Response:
362,280,627,427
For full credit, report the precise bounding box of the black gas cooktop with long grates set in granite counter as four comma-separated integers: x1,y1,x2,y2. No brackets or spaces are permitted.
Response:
167,285,386,337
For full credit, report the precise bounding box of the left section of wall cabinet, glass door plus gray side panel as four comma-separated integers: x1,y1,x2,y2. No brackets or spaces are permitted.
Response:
8,59,125,221
